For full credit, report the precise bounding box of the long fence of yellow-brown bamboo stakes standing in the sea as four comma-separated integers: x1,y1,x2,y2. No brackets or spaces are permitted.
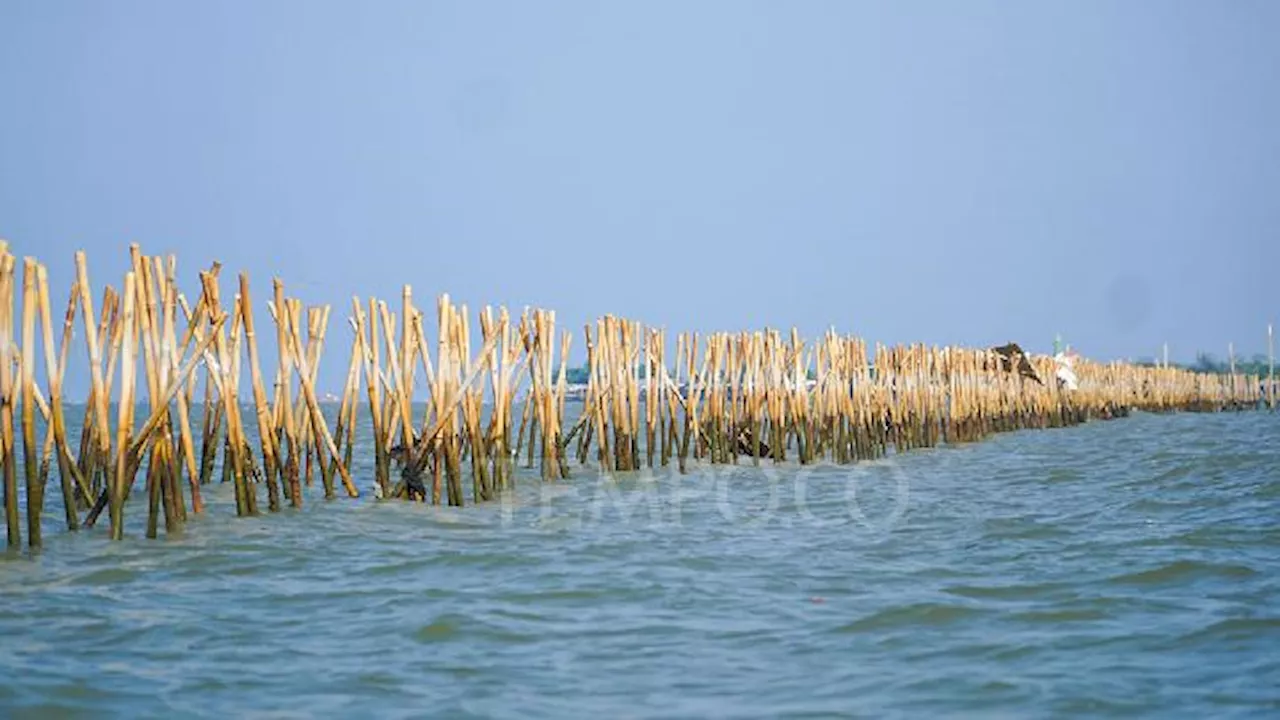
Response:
0,241,1263,547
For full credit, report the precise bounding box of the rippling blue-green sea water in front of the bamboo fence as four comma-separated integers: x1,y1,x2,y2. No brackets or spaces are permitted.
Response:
0,413,1280,719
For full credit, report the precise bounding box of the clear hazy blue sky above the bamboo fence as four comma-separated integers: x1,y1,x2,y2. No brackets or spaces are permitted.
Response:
0,0,1280,392
